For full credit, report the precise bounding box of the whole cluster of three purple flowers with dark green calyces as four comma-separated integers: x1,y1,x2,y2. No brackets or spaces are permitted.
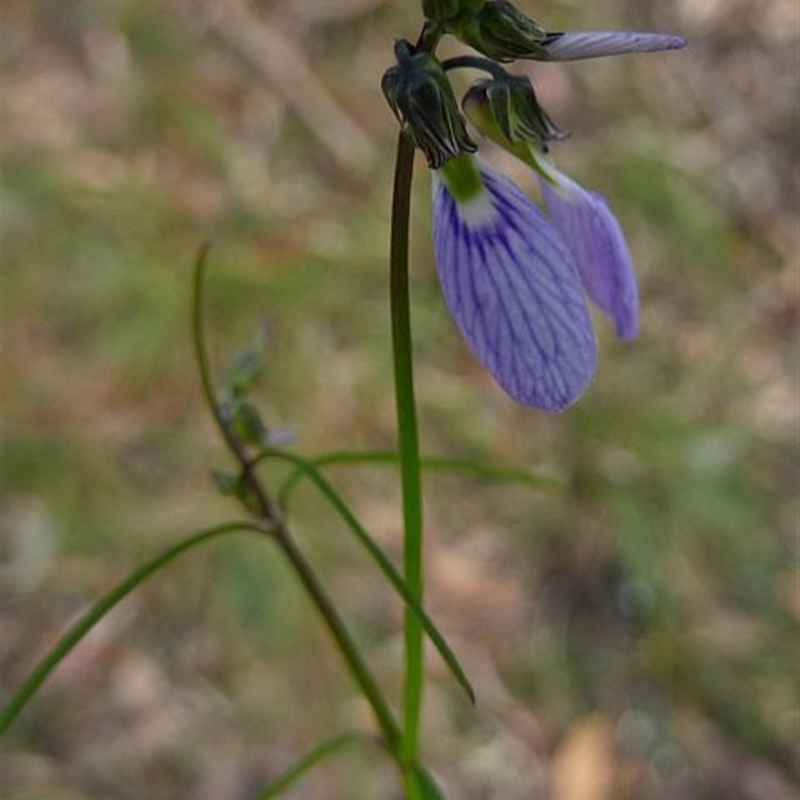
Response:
382,10,686,411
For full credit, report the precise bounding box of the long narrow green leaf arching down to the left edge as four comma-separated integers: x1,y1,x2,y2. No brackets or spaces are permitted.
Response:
0,522,265,736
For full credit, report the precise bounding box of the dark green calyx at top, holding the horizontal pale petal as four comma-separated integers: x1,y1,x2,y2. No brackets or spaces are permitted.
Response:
456,0,547,61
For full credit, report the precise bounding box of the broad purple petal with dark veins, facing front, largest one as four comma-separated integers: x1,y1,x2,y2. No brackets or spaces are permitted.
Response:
433,162,597,411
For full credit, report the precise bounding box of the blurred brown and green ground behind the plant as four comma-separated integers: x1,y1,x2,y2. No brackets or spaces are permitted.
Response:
0,0,800,800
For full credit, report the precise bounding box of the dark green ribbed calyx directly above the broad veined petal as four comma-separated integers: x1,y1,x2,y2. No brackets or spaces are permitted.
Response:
381,41,477,169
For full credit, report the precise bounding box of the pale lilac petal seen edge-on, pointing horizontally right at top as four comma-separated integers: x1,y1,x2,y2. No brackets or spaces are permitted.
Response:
543,31,687,61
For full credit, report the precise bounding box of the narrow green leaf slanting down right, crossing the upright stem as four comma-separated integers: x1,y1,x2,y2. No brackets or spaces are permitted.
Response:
258,450,475,703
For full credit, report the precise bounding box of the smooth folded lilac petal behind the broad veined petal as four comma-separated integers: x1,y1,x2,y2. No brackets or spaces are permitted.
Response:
540,173,639,339
